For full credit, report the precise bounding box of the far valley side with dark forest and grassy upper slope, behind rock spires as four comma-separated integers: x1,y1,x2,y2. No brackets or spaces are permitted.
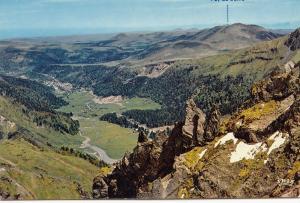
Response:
28,37,295,127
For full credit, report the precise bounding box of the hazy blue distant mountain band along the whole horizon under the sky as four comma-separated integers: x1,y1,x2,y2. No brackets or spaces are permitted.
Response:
0,23,283,68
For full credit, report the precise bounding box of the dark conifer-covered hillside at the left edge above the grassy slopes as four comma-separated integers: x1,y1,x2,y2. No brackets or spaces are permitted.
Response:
0,75,79,140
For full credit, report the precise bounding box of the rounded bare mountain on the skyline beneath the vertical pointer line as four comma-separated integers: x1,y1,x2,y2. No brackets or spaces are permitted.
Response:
127,23,283,61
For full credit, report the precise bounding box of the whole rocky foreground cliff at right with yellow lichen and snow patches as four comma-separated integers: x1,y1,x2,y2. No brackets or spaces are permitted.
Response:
93,28,300,199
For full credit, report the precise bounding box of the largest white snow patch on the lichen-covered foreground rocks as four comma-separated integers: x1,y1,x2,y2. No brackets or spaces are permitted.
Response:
230,141,267,163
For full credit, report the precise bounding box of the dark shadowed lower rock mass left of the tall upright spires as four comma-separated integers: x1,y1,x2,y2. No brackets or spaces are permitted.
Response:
93,133,175,198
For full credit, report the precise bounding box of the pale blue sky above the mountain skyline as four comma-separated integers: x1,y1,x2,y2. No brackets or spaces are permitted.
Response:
0,0,300,39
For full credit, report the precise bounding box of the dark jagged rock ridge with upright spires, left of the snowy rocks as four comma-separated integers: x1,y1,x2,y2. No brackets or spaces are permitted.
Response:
93,99,220,199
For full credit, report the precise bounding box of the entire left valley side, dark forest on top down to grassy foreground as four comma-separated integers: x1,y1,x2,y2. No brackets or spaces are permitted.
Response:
0,76,100,200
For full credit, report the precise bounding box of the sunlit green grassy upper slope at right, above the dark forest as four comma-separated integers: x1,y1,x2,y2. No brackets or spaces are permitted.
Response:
175,37,288,80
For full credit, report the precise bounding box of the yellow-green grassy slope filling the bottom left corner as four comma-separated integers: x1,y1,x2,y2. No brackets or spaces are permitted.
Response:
0,139,98,199
